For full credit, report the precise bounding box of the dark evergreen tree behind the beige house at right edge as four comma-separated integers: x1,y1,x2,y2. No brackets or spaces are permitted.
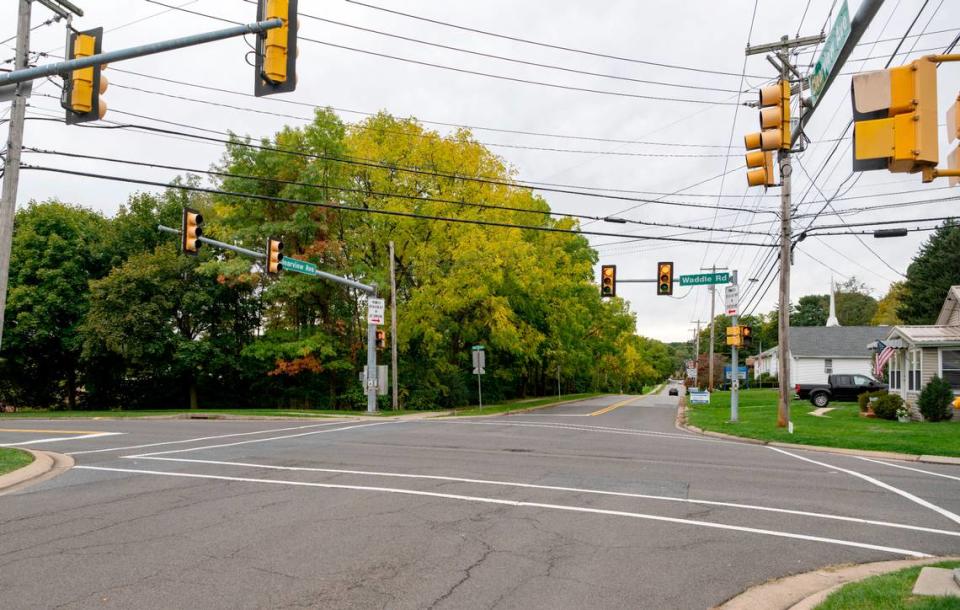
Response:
897,220,960,324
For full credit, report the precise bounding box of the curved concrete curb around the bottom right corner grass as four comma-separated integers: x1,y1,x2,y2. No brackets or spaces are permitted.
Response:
714,557,958,610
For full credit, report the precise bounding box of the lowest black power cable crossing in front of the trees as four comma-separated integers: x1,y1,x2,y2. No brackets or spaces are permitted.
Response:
22,165,780,247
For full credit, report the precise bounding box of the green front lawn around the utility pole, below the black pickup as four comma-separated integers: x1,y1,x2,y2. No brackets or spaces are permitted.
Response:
687,390,960,457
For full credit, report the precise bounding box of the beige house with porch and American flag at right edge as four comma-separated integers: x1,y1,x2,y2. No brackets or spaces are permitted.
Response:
874,286,960,404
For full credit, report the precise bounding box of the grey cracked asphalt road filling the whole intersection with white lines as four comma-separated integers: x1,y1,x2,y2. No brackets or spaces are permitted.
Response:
0,395,960,609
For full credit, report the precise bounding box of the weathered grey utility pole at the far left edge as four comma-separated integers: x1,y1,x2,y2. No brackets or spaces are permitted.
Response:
0,0,30,347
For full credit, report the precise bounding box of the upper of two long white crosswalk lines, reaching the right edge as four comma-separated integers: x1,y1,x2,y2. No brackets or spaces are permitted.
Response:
129,457,960,537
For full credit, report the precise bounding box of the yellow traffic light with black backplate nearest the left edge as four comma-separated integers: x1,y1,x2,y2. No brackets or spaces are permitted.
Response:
60,28,107,125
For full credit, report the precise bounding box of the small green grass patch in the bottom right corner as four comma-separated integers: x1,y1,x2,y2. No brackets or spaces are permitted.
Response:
816,561,960,610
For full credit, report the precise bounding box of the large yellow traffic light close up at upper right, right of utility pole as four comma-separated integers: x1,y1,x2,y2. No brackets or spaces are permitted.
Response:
851,57,940,173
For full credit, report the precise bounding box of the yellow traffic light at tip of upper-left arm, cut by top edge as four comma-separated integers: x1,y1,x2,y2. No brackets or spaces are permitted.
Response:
253,0,299,97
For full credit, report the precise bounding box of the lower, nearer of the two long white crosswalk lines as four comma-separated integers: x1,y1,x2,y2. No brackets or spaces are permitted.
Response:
74,466,931,557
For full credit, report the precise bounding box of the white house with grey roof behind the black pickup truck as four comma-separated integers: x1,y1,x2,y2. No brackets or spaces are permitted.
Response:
754,326,890,386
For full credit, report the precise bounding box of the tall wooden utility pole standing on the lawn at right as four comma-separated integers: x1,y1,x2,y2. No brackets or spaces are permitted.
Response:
777,52,793,429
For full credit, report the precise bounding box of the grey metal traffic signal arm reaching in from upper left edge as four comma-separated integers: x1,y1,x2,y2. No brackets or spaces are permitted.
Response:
0,19,283,85
